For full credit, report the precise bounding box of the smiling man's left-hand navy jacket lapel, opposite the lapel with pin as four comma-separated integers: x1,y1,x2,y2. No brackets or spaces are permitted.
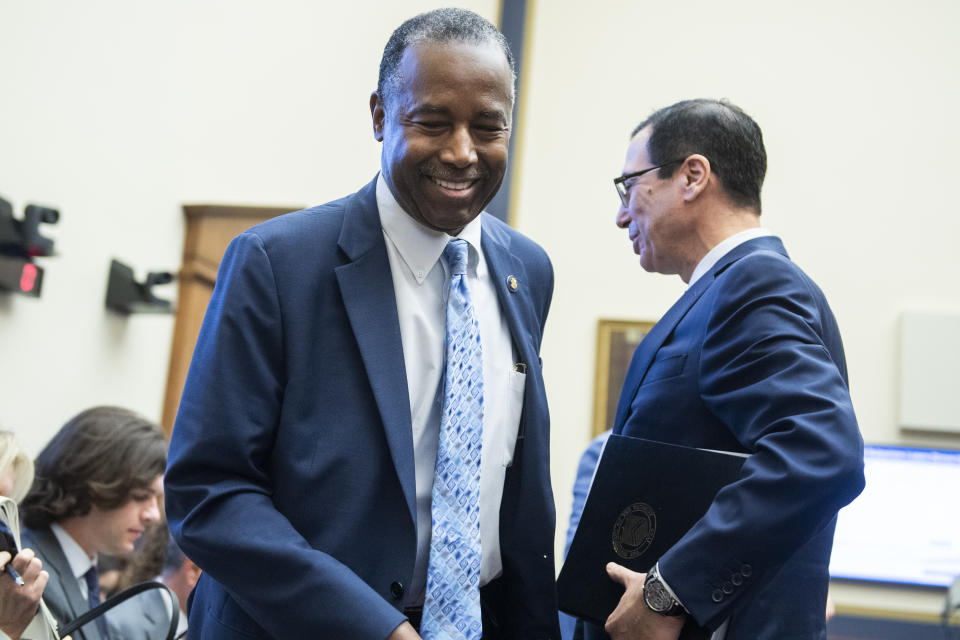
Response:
335,180,416,522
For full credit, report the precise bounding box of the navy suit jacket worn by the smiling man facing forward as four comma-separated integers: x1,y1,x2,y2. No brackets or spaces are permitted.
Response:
166,182,559,640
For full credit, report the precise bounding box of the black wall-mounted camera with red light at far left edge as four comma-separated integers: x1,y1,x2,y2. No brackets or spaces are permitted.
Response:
0,198,60,298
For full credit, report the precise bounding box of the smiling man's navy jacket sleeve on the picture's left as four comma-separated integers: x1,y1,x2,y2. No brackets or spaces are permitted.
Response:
165,232,404,639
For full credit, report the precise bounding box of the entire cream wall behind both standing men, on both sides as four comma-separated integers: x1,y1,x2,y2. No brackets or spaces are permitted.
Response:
0,0,960,620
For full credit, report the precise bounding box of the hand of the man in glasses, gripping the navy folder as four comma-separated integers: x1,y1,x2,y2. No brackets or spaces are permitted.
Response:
604,562,686,640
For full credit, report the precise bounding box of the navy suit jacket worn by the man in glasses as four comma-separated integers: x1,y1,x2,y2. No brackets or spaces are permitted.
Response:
614,237,864,640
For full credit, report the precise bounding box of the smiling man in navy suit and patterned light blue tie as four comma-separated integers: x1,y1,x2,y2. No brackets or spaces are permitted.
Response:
166,9,559,640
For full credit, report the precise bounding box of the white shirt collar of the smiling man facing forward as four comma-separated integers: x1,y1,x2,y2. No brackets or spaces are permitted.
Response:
377,173,485,284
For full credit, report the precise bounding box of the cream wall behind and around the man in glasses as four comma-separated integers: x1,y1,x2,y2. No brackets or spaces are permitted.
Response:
515,0,960,612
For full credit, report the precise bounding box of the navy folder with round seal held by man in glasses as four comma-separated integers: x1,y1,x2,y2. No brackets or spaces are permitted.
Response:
557,435,745,640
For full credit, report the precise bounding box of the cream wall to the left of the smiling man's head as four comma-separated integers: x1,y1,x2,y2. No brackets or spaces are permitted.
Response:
0,0,499,453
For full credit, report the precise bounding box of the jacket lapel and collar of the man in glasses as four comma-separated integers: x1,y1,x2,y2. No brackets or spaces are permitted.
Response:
613,236,789,433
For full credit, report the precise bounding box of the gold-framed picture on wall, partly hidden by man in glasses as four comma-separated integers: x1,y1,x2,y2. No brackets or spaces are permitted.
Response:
593,318,654,436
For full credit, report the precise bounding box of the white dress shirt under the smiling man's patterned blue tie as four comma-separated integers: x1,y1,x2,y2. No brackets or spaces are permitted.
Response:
377,175,526,606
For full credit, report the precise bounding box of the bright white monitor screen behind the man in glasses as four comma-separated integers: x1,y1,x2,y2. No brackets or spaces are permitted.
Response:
830,445,960,587
